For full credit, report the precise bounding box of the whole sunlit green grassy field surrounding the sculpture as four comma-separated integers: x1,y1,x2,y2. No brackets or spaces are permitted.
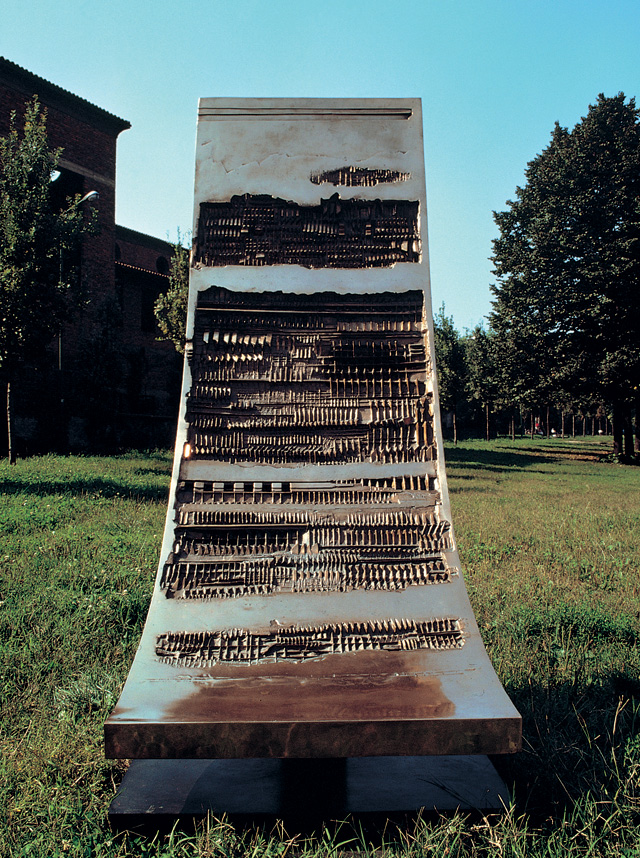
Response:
0,439,640,858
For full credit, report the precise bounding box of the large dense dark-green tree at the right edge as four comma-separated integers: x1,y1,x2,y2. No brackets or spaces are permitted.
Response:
491,93,640,453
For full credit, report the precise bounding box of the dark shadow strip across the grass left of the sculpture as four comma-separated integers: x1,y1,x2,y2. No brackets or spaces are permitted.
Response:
0,471,169,503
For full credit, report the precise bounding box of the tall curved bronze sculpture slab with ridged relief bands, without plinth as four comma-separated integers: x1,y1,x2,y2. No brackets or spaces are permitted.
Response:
105,99,520,758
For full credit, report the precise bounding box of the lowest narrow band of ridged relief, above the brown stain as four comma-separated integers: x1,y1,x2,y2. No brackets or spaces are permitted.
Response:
156,617,464,668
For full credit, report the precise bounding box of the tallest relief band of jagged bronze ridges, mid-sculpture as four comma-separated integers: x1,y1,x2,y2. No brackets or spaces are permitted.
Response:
187,289,435,464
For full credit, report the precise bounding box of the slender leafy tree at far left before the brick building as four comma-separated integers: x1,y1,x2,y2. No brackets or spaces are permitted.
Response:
0,97,95,461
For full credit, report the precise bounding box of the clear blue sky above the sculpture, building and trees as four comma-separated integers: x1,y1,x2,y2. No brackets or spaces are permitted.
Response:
0,0,640,329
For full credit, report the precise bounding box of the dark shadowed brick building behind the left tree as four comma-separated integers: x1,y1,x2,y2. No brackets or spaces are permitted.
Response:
0,57,181,452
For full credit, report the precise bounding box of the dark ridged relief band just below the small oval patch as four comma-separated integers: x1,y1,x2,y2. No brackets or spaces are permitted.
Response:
195,194,420,268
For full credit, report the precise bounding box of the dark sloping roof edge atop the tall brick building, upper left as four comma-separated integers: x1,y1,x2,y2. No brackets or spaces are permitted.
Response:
0,57,131,137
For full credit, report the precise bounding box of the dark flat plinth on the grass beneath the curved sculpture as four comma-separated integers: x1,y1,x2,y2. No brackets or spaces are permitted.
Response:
109,756,509,824
